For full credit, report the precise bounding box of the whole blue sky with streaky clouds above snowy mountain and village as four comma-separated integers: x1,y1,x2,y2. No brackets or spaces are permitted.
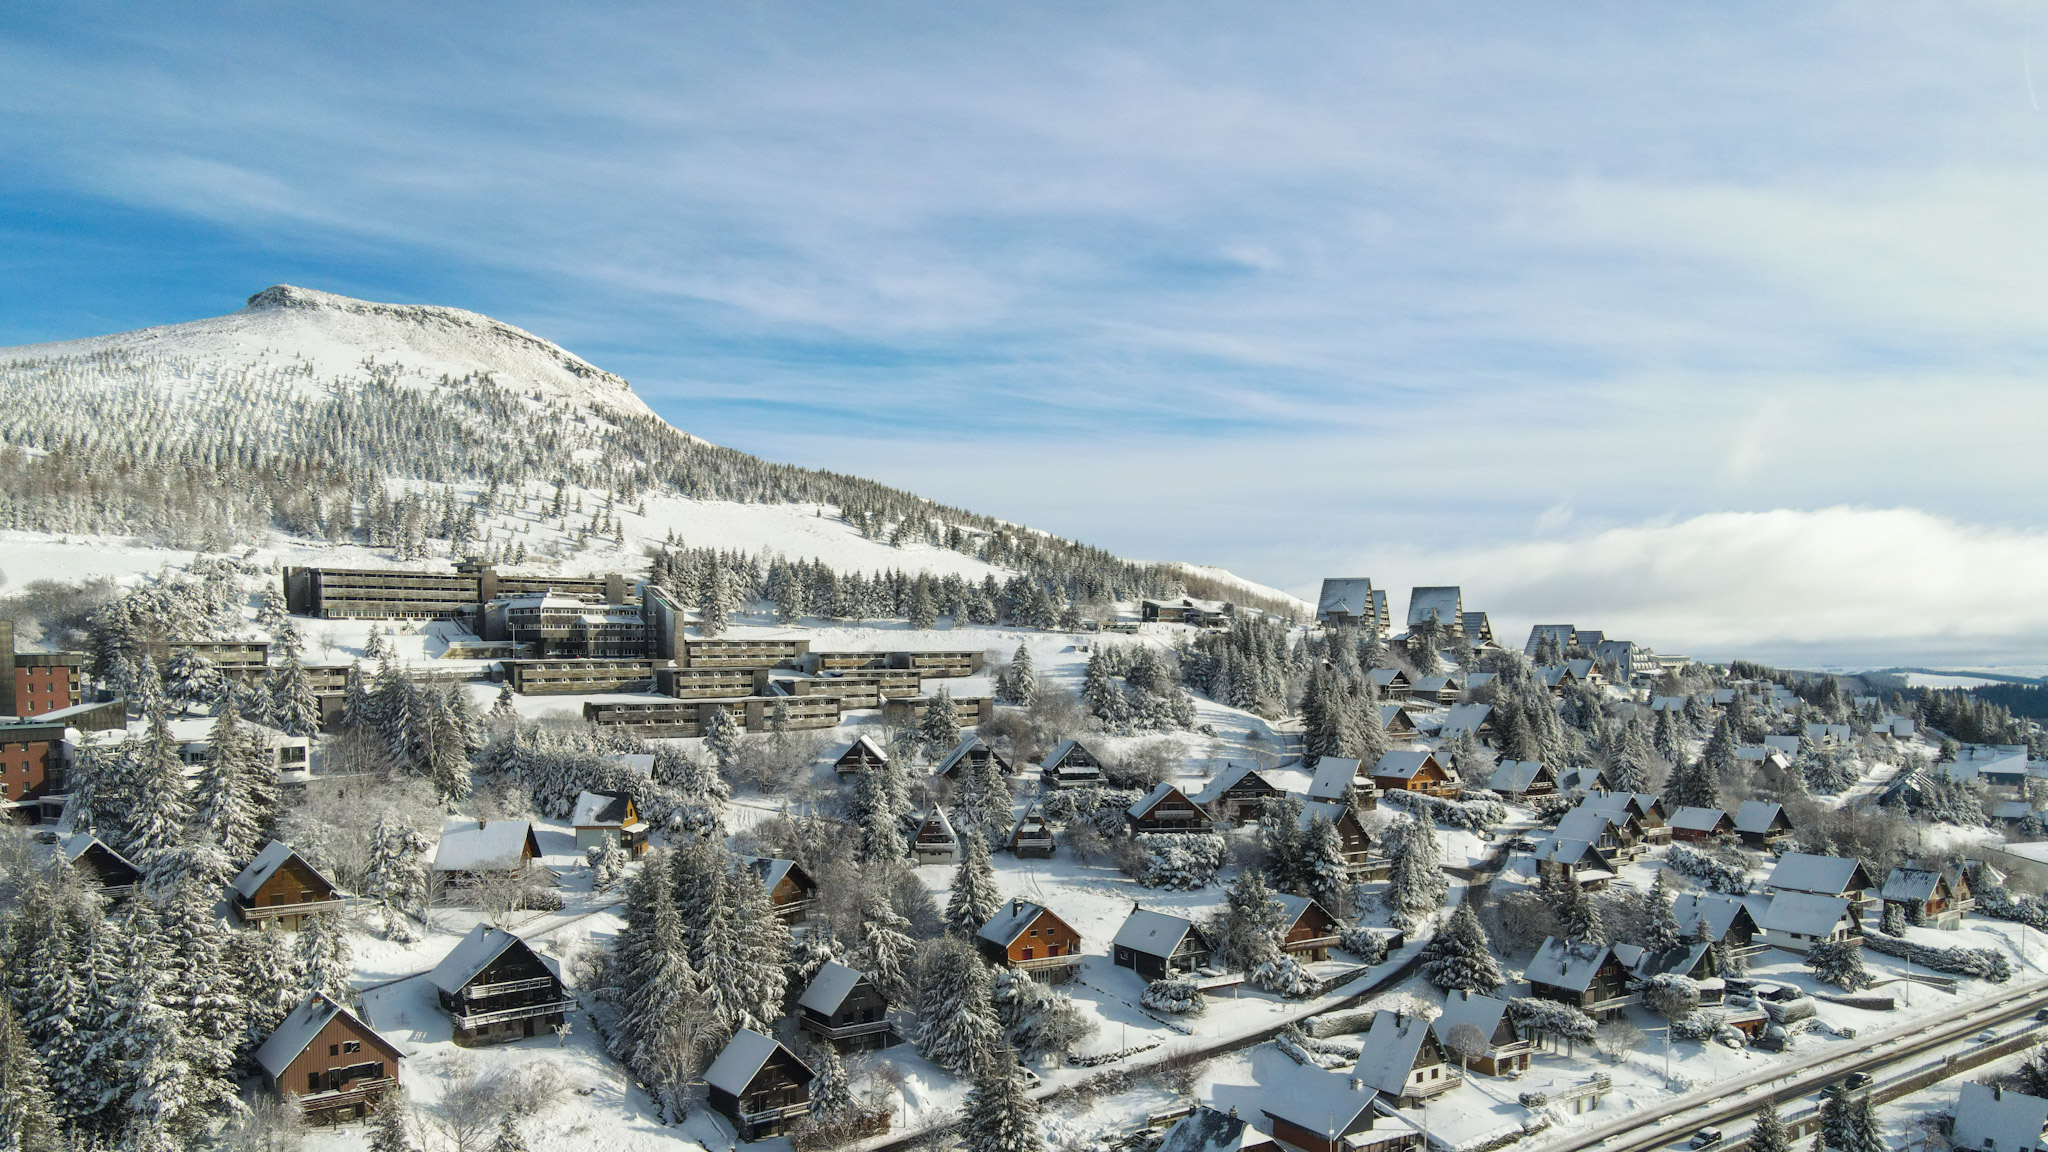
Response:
0,0,2048,662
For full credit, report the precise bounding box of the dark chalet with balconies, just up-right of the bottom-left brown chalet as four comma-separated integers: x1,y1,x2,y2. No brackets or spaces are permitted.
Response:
426,924,575,1047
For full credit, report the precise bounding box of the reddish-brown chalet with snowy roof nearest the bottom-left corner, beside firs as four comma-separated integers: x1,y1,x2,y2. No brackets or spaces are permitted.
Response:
256,992,406,1119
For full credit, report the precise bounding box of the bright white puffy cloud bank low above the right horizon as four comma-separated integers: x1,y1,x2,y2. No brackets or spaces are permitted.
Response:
1354,506,2048,664
